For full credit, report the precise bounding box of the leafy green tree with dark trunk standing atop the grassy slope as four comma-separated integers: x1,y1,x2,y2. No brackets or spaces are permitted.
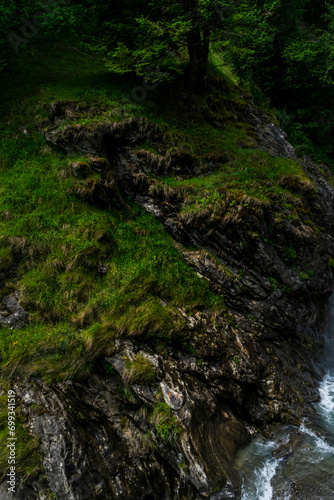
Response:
95,0,232,83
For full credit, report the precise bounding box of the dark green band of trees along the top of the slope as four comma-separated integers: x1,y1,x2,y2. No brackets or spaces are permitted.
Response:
0,0,334,159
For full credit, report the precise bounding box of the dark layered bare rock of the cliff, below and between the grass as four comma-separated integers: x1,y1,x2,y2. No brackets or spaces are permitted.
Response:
0,98,334,500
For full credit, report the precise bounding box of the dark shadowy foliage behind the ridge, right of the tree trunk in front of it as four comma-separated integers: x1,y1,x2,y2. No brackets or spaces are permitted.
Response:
220,0,334,161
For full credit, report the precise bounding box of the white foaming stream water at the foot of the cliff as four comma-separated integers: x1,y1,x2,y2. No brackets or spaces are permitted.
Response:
238,302,334,500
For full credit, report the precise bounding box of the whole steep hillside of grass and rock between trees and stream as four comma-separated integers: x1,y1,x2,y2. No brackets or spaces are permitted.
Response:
0,47,334,500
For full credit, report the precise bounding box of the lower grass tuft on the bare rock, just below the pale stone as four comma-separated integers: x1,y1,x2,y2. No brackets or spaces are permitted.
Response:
151,403,182,444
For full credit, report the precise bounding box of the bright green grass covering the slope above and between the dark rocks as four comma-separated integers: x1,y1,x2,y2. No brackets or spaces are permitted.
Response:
0,40,310,480
